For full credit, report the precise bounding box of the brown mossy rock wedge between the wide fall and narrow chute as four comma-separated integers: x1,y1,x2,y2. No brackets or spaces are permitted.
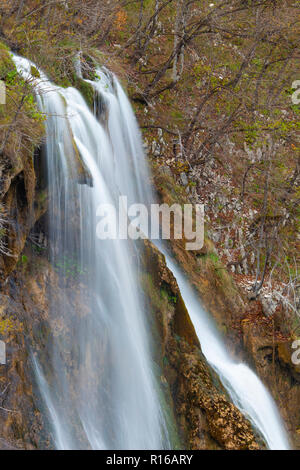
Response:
142,241,260,450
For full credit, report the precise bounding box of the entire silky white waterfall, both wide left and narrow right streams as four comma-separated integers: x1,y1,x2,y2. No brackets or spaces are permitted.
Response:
14,56,288,449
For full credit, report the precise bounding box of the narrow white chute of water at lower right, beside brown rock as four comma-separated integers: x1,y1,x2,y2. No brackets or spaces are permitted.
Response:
162,254,289,450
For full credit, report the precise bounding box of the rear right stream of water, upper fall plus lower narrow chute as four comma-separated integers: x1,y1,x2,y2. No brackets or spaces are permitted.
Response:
87,65,289,449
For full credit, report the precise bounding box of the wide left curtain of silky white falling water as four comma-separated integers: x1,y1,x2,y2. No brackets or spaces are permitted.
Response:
14,56,169,449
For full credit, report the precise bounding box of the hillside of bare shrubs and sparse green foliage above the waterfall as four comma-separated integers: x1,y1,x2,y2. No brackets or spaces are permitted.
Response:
0,0,300,312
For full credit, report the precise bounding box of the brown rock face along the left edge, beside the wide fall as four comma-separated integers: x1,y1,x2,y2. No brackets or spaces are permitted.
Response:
0,131,50,449
